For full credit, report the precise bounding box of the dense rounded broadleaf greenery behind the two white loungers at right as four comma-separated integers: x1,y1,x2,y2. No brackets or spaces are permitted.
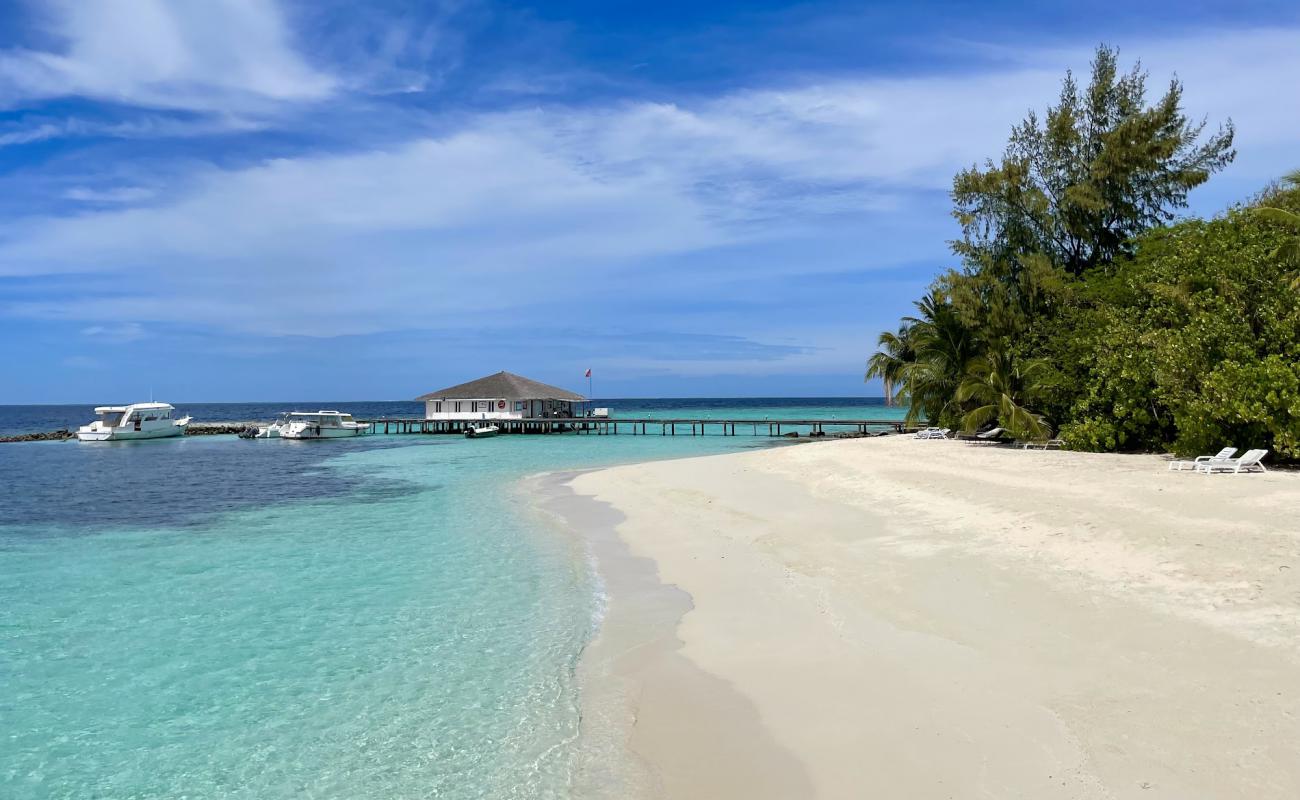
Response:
1043,187,1300,458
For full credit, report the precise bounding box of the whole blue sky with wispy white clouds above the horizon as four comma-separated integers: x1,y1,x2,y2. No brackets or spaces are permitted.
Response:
0,0,1300,403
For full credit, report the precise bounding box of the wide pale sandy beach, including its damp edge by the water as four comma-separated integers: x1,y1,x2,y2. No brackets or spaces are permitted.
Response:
562,437,1300,800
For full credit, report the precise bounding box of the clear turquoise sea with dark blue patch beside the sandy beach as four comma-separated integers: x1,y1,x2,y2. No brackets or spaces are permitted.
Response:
0,401,894,799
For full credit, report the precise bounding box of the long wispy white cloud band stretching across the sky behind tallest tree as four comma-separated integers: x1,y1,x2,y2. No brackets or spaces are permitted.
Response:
0,31,1300,361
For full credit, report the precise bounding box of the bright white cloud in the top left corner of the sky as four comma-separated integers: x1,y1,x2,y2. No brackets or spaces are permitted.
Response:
0,0,335,112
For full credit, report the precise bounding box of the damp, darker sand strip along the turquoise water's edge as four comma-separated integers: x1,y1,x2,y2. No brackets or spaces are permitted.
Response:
529,462,810,800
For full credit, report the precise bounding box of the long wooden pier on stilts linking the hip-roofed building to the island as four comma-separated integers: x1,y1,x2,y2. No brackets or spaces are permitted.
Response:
358,416,904,436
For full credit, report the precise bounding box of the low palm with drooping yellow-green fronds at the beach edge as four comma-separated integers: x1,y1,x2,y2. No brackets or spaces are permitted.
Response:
957,347,1052,440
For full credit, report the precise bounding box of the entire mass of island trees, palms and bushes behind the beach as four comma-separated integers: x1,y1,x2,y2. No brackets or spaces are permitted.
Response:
867,47,1300,459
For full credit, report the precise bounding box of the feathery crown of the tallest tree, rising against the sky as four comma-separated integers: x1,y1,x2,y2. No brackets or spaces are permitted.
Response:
953,46,1235,278
